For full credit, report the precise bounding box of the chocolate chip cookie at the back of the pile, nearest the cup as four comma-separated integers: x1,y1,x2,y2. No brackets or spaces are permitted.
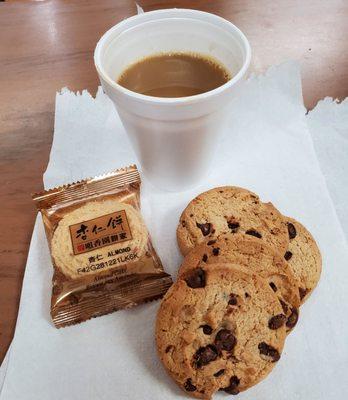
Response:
177,186,289,255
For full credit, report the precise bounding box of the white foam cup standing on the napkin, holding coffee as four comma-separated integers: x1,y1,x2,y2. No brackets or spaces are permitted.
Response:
94,9,251,191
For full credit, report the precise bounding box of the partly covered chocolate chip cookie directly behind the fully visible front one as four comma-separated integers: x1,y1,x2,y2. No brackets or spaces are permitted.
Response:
179,233,300,332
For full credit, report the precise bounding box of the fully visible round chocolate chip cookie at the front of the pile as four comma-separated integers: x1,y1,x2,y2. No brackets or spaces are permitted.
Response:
156,264,286,399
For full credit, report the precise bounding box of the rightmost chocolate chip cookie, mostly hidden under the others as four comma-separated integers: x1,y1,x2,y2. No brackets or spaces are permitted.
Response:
284,217,321,304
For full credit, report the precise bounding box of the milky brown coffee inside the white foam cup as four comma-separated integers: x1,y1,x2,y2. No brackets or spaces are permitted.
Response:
117,53,231,97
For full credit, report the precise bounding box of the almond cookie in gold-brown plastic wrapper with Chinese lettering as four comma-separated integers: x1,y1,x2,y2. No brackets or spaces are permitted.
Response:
33,166,172,328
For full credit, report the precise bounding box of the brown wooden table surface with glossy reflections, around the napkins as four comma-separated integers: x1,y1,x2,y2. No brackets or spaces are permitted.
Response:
0,0,348,362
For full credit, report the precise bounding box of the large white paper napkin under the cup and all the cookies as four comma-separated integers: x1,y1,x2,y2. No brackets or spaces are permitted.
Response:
1,63,348,400
